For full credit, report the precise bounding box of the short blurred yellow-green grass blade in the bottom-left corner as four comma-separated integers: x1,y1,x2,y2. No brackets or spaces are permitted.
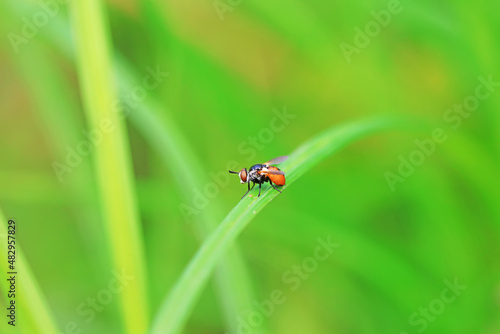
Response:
0,209,59,334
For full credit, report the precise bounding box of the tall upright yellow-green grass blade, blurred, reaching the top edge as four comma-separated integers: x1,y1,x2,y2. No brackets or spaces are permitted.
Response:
71,0,149,333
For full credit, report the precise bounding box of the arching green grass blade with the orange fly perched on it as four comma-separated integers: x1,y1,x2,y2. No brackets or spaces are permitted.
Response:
152,118,408,334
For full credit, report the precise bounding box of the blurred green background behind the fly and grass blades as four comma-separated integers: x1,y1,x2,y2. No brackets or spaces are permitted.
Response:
0,0,500,334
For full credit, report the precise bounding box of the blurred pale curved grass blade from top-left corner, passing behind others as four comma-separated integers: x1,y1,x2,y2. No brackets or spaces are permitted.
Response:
0,1,258,333
